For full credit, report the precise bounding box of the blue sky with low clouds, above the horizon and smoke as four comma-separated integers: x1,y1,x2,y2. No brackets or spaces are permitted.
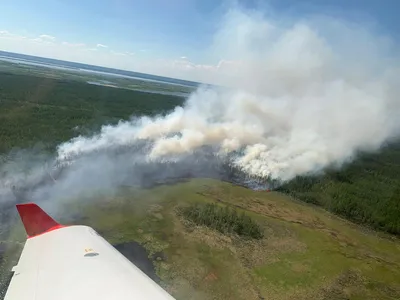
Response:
0,0,400,81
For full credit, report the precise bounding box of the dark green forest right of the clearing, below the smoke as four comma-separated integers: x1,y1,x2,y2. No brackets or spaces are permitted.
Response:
278,142,400,235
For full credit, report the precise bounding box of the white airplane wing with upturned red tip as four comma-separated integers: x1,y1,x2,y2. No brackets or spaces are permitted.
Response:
5,203,174,300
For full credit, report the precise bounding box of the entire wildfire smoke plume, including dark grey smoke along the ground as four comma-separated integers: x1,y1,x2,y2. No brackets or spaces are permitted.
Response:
0,9,400,211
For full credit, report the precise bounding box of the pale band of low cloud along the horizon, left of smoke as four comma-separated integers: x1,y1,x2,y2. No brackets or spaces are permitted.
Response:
0,30,235,82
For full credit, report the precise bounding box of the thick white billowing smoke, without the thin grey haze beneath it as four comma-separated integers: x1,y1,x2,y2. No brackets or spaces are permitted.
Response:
58,10,400,180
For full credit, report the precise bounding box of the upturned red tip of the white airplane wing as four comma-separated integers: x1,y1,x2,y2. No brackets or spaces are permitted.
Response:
17,203,64,238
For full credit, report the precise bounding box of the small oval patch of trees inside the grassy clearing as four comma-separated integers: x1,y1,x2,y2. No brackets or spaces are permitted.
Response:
180,204,263,239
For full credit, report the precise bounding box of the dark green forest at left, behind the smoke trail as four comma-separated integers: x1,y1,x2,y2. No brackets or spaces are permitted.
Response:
0,73,184,153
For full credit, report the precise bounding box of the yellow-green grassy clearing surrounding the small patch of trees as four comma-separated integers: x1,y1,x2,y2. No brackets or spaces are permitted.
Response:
6,179,400,300
